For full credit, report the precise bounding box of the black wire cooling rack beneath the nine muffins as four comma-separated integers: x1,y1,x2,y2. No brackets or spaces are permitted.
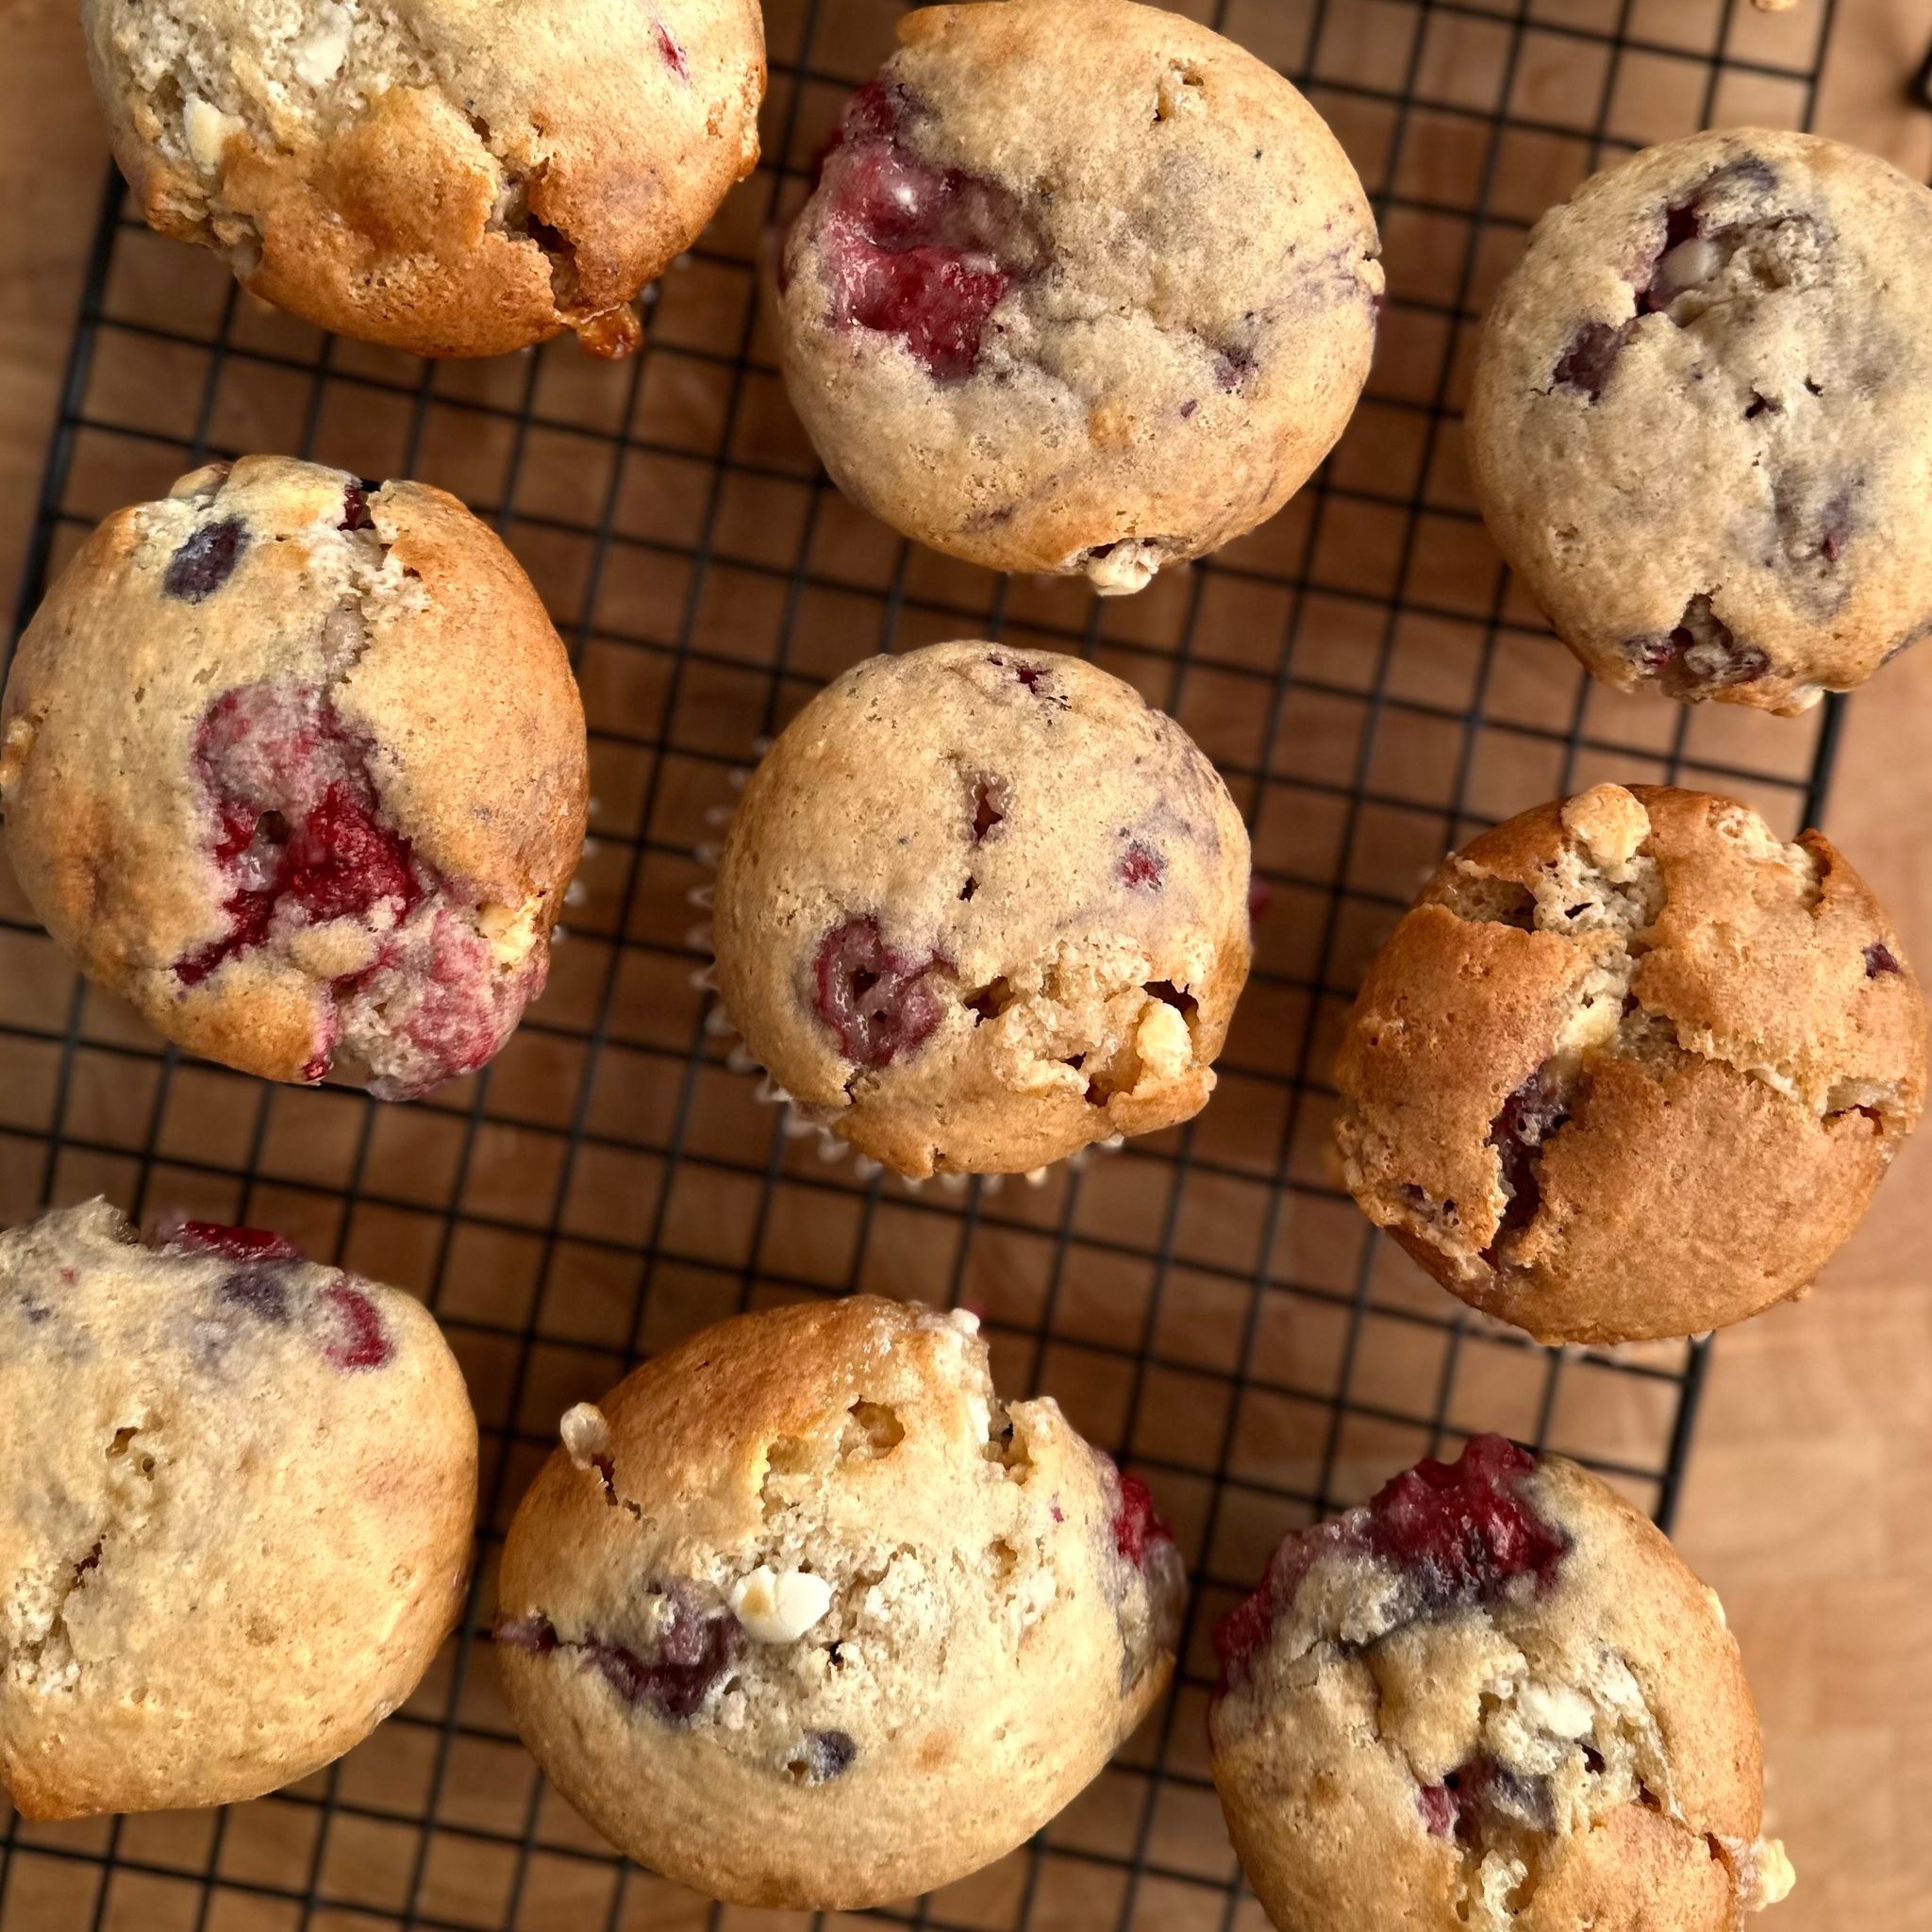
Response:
0,0,1870,1932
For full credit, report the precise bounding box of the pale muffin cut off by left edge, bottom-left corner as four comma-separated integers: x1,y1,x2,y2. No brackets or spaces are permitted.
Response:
0,1200,477,1818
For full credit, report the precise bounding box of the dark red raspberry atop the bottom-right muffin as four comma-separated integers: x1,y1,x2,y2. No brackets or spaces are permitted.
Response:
1364,1436,1569,1613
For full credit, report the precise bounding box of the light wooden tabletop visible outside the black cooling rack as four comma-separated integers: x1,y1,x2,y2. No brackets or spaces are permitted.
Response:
0,0,1932,1932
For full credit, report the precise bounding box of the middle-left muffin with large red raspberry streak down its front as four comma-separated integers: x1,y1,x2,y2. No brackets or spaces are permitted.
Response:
0,456,588,1099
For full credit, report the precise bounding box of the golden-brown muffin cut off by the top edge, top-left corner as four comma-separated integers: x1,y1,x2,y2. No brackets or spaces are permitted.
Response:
81,0,765,356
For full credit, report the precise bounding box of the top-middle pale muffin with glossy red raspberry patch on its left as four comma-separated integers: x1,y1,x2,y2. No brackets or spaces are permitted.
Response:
778,0,1381,593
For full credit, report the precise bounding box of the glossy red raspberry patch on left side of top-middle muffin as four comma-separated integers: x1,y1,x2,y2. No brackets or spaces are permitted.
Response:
808,81,1034,383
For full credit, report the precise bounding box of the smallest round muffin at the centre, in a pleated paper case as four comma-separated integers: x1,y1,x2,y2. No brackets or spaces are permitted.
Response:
715,643,1248,1174
